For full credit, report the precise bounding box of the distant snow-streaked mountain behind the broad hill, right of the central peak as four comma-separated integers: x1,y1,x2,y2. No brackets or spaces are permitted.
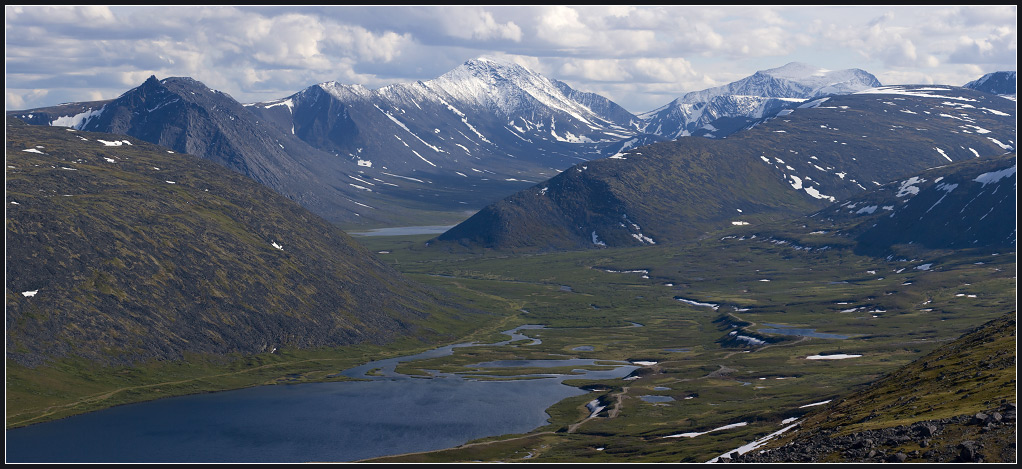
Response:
640,62,881,139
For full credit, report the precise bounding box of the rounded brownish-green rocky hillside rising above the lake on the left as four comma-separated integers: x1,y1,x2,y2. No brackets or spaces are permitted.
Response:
5,120,468,366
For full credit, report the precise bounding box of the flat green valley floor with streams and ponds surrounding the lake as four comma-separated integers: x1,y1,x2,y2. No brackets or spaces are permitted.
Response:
7,229,1016,462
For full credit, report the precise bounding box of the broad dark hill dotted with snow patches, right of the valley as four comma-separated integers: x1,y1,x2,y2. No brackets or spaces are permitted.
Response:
436,87,1015,248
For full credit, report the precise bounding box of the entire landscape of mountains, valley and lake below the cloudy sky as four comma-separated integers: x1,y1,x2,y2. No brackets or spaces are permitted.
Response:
5,31,1017,463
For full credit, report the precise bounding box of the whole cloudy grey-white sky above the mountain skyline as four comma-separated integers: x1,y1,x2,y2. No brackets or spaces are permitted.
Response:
4,5,1018,113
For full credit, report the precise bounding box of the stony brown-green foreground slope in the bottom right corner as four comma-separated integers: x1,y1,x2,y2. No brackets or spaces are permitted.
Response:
729,312,1017,463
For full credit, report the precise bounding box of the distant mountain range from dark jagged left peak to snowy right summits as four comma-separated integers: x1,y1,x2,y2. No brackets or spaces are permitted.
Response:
7,58,879,227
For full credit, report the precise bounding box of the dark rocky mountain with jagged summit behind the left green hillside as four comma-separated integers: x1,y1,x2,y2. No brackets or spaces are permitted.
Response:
7,77,461,226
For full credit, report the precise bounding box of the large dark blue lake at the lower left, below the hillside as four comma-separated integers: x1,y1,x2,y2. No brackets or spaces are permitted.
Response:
6,326,638,462
